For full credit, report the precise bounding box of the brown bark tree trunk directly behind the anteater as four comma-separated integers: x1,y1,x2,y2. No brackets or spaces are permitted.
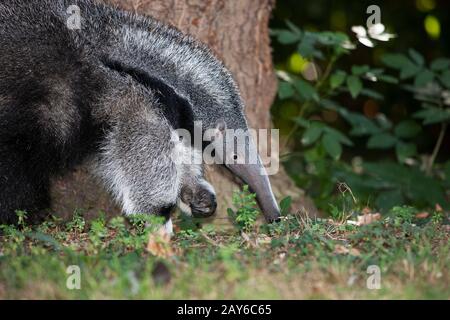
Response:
50,0,316,221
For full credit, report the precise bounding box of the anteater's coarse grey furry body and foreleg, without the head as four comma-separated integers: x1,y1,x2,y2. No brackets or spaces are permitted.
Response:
0,0,282,228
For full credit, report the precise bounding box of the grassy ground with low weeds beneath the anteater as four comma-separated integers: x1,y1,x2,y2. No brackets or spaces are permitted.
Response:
0,192,450,299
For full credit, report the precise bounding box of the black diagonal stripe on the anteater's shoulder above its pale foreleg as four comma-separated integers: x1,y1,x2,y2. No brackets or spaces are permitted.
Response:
101,58,194,134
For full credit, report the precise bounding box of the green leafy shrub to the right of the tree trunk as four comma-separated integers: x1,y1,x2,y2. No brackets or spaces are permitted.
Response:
272,22,450,212
